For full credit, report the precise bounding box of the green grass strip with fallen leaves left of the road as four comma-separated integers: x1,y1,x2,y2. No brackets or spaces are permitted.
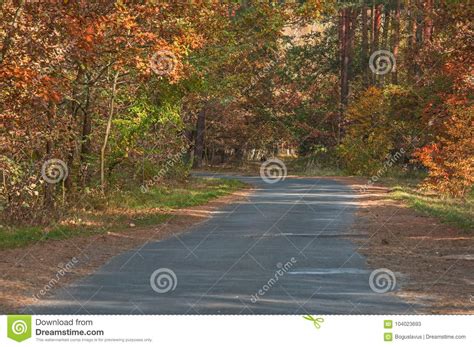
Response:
0,178,245,249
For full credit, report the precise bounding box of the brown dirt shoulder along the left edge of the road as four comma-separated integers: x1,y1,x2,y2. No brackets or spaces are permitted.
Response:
0,189,252,314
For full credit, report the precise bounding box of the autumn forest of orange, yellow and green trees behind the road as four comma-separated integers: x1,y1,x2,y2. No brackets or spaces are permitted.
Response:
0,0,474,225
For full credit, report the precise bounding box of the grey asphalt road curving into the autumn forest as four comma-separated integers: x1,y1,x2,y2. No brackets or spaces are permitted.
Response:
24,177,416,314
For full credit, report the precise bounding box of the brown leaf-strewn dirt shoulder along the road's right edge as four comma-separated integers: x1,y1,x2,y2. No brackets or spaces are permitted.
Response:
336,178,474,314
